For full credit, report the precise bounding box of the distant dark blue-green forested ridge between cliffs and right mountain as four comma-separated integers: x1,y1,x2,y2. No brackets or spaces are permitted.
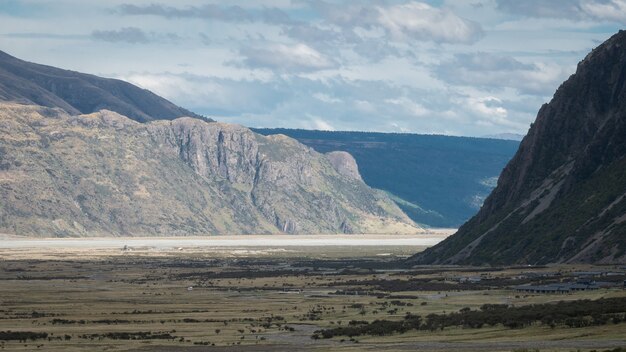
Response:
253,129,519,227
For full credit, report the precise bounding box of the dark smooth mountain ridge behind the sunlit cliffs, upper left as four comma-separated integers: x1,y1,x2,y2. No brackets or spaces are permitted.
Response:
0,51,202,122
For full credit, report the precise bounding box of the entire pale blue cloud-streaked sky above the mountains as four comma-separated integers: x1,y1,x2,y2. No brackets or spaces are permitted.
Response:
0,0,626,137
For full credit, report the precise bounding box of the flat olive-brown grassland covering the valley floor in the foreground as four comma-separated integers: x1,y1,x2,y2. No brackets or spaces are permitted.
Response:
0,241,626,351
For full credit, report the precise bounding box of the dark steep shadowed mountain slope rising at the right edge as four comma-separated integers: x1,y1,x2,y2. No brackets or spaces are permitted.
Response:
410,31,626,264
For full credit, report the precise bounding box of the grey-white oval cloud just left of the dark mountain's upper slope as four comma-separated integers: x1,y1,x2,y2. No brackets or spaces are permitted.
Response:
435,52,568,96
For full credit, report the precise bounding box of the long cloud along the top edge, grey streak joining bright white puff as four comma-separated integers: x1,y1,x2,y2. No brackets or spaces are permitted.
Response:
116,1,483,48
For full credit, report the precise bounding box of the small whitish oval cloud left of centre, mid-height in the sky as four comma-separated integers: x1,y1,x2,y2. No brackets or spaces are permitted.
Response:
234,44,336,72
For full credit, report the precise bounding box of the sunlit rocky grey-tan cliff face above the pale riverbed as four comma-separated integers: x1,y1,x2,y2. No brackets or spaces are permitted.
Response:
0,104,419,236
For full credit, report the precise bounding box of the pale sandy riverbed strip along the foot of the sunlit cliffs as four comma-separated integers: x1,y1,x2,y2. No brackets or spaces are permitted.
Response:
0,229,454,259
